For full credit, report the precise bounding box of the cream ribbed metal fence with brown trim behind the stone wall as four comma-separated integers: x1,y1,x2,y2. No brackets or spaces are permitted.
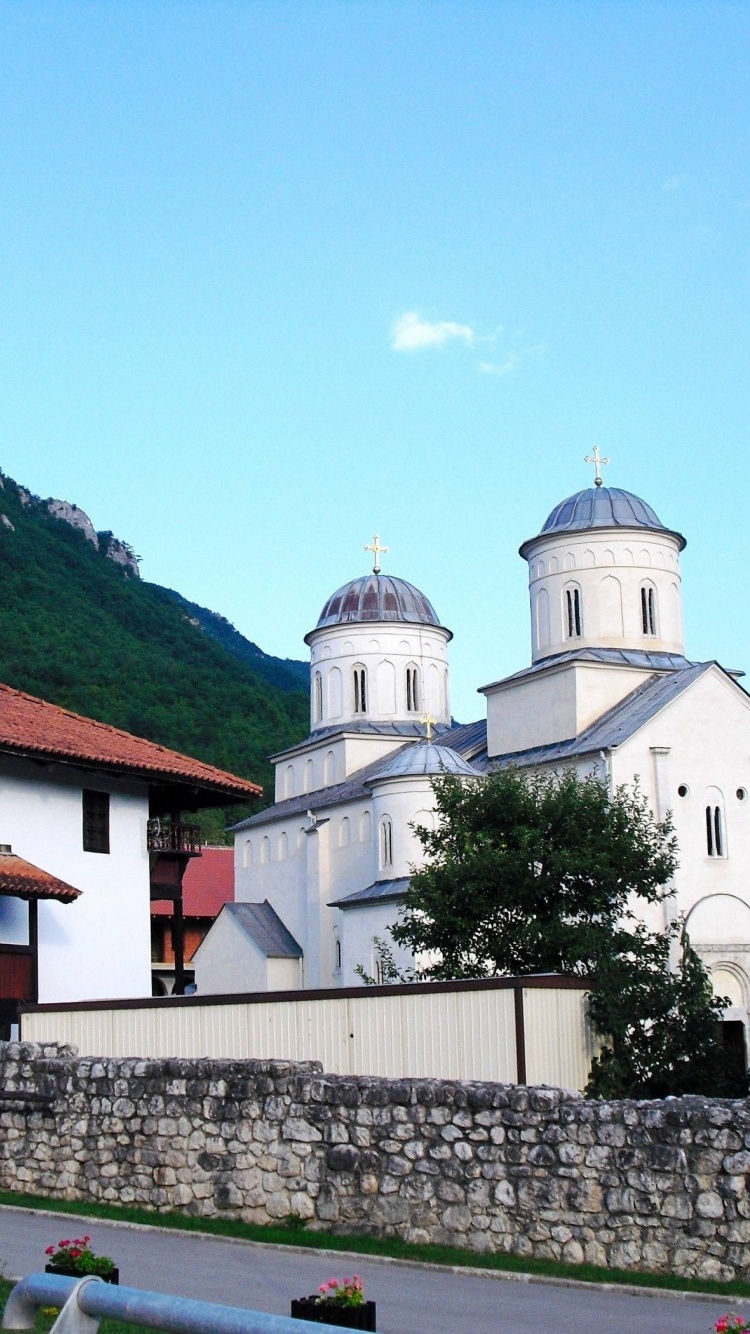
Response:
21,987,595,1089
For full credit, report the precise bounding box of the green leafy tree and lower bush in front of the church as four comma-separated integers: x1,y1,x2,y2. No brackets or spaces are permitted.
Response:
391,770,739,1097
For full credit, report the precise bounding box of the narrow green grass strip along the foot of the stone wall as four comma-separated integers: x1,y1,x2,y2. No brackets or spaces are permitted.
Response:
0,1190,750,1298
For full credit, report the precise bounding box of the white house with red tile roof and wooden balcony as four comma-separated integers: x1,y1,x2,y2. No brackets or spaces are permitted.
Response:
0,686,260,1031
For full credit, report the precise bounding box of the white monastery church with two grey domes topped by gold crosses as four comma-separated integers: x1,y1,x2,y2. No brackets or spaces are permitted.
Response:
195,454,750,1021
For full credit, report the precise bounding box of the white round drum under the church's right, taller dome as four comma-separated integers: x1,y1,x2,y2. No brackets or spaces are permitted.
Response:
528,528,685,662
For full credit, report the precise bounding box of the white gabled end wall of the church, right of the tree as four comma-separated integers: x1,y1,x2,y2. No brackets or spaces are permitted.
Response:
611,668,750,1005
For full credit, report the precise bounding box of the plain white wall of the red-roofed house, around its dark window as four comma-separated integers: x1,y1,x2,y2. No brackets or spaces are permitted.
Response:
0,759,151,1003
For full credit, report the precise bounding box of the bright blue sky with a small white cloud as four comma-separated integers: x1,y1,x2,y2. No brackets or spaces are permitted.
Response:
0,0,750,719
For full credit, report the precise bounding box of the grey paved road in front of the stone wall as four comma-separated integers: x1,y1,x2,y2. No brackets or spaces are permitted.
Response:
0,1207,750,1334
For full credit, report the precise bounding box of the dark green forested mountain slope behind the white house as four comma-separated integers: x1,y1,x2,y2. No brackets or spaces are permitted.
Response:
0,476,308,795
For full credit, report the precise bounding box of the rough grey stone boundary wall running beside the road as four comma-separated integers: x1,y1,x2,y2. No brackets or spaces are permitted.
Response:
0,1043,750,1279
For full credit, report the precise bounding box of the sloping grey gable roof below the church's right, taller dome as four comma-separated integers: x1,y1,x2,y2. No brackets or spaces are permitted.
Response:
491,662,715,768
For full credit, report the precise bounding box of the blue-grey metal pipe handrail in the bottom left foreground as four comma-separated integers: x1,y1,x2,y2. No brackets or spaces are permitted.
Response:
3,1274,354,1334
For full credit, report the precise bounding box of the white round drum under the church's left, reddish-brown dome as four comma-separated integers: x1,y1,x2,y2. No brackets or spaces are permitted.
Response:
305,622,450,731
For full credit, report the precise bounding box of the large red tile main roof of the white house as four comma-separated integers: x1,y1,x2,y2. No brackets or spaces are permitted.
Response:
0,686,262,800
